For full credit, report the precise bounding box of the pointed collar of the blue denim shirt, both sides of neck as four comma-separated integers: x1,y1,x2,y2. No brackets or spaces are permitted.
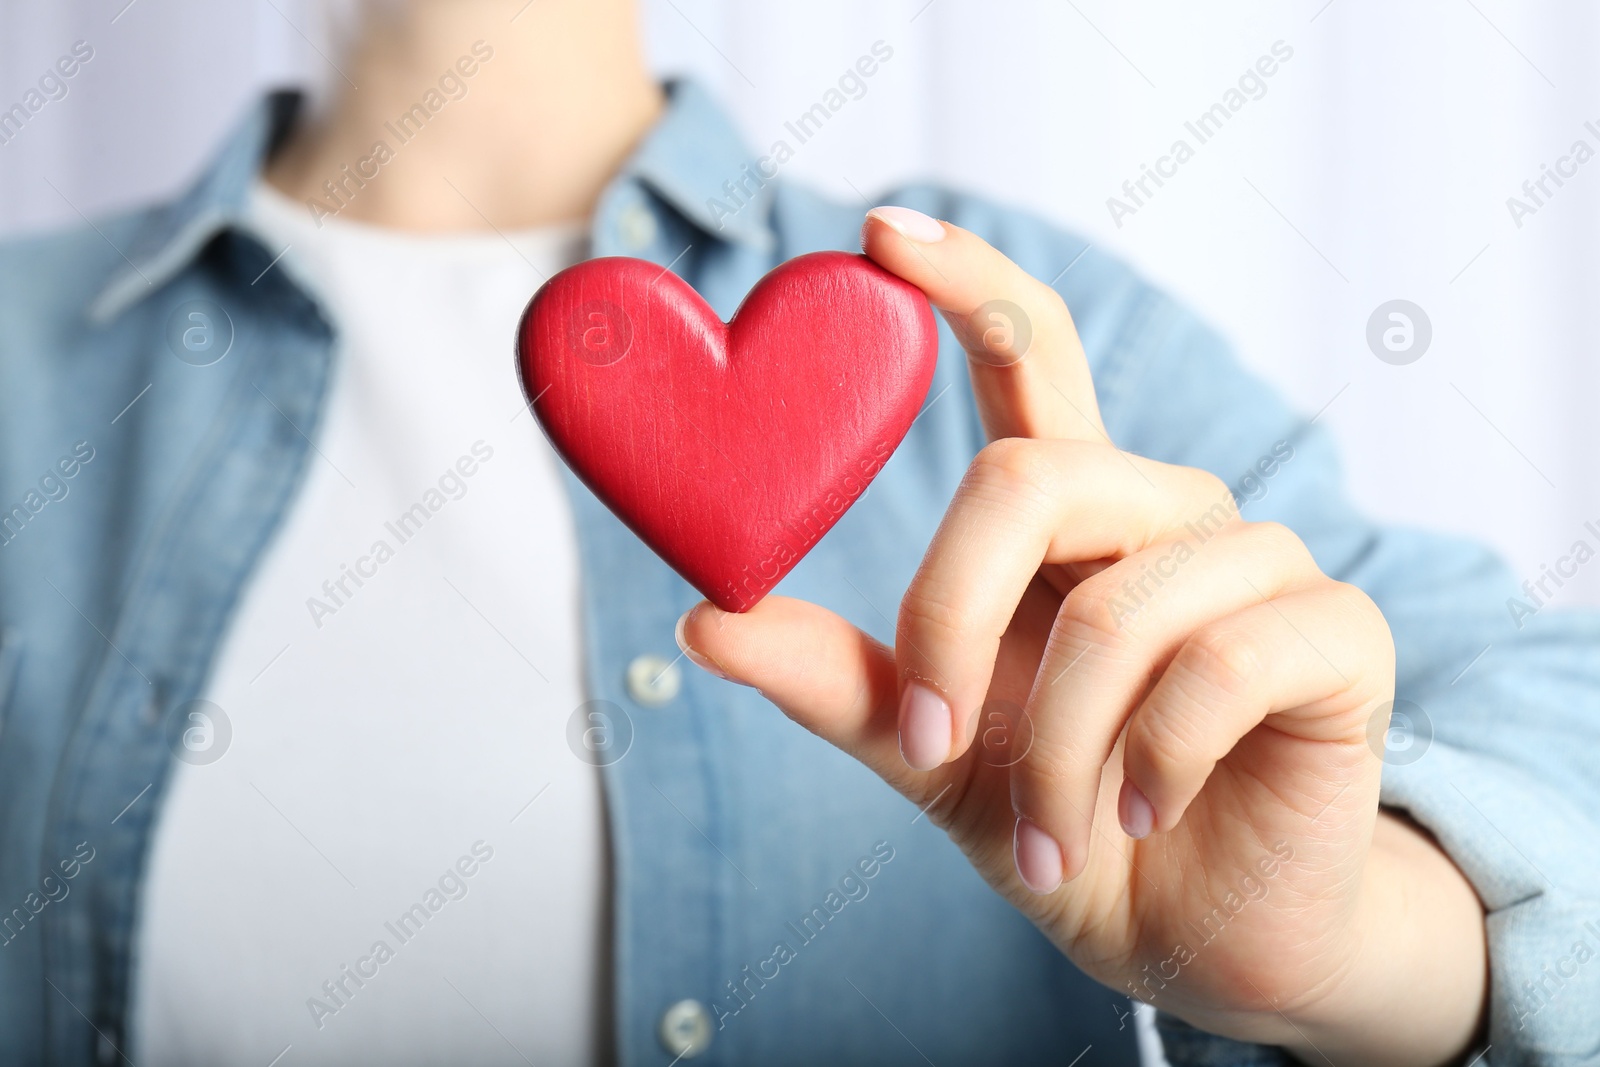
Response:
90,82,773,322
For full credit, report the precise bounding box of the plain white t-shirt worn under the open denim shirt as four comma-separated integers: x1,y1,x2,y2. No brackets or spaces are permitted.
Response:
130,184,610,1067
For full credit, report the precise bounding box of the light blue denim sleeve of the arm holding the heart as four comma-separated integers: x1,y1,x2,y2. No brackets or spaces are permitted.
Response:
1093,291,1600,1067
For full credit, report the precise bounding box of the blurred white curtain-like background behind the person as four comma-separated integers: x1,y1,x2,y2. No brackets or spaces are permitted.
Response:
0,0,1600,605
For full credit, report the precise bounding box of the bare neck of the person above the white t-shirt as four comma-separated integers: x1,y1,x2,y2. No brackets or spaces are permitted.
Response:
266,0,664,230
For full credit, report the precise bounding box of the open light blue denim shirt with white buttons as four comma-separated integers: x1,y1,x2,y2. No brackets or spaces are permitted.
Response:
0,83,1600,1067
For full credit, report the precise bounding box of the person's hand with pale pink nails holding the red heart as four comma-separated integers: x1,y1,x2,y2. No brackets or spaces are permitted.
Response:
678,208,1486,1064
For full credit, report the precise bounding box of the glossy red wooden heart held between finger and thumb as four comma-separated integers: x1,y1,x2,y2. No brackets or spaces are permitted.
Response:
517,253,939,611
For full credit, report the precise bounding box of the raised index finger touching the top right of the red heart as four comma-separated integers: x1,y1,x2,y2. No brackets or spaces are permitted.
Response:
861,206,1109,443
